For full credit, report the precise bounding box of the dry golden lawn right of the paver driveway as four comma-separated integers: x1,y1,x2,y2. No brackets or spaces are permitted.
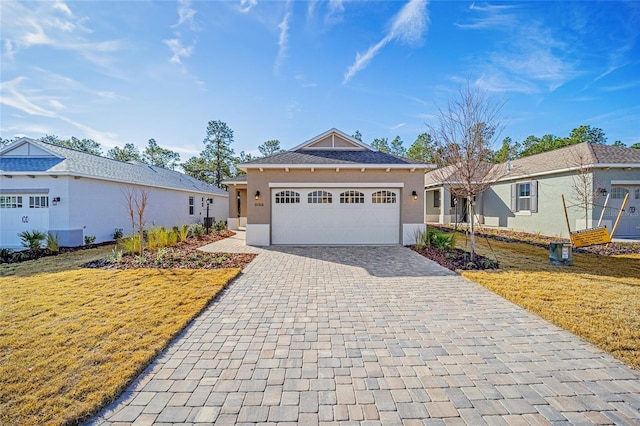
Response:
458,238,640,368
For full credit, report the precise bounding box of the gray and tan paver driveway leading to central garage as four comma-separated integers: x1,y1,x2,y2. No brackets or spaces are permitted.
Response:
91,234,640,425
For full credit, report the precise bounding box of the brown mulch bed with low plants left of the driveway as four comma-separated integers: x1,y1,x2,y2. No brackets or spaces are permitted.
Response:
83,230,256,269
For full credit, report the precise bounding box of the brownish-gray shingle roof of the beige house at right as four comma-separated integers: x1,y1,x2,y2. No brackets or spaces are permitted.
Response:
425,142,640,185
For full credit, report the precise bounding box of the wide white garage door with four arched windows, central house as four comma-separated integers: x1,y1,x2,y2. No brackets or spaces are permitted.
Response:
271,187,400,244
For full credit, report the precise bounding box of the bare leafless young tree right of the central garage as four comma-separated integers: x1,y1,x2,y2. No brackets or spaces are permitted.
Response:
428,82,507,260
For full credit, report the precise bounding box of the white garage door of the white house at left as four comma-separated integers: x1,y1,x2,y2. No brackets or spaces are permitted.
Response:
0,191,49,249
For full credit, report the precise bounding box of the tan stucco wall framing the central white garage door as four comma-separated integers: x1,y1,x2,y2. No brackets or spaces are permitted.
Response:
247,169,424,224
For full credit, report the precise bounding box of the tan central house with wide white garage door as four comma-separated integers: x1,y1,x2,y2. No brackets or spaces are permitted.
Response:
224,129,428,246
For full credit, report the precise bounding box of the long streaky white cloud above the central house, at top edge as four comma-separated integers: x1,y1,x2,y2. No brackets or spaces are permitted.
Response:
343,0,429,84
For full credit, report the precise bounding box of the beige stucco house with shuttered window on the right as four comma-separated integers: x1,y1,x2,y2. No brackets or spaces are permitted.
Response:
425,143,640,238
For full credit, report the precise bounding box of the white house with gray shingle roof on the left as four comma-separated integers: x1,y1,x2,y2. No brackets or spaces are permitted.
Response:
0,138,228,248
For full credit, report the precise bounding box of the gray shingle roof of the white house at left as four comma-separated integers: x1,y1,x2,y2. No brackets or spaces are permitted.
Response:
0,138,228,196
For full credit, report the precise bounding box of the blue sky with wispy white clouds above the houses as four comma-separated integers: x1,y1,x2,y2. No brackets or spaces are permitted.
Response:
0,0,640,161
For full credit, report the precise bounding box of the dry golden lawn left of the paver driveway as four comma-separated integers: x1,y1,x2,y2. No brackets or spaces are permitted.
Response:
0,248,240,425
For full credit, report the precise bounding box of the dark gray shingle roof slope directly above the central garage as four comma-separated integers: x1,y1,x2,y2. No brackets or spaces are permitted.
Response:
243,150,423,167
